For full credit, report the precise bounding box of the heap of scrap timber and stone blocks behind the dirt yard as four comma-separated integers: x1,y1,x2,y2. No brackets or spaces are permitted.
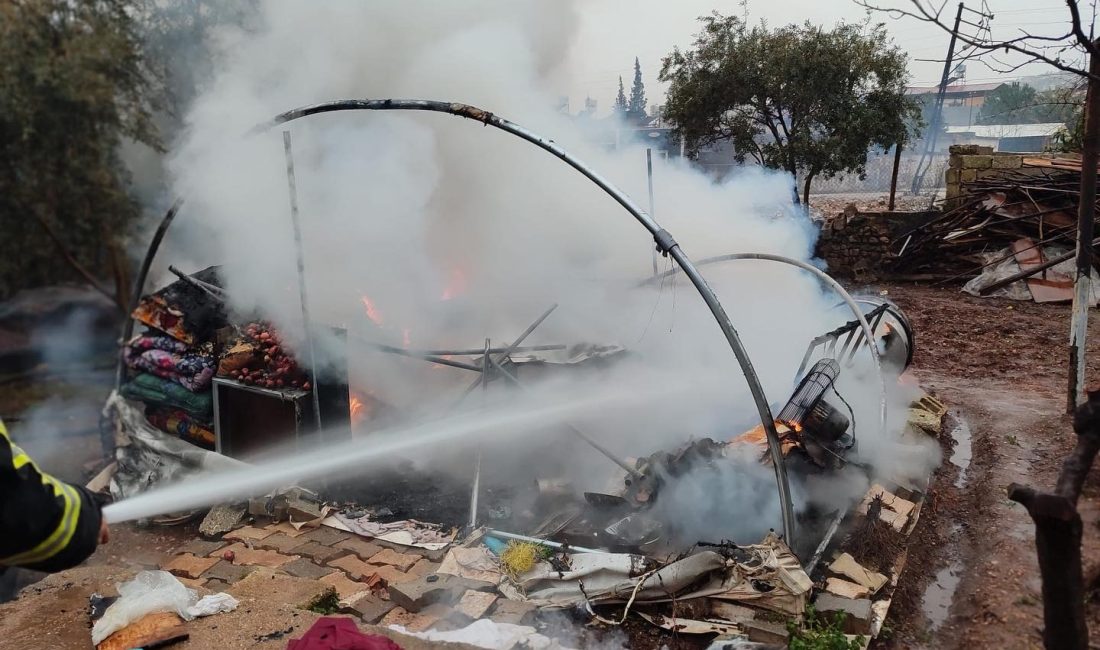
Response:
817,145,1096,302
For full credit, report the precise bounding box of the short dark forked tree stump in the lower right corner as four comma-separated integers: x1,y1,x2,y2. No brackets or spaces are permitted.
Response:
1009,392,1100,650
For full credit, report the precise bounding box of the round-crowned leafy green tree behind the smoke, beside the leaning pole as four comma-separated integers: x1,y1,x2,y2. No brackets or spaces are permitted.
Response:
660,12,920,202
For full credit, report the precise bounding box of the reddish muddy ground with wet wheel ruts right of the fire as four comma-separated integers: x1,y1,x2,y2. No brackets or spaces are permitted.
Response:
875,285,1100,650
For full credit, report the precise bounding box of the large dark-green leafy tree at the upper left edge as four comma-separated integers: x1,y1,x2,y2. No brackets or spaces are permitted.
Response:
0,0,160,299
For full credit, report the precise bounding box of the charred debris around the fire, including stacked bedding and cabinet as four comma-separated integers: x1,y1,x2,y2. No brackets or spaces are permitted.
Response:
100,263,945,643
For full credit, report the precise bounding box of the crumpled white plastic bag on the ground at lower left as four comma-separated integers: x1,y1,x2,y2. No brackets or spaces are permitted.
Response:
91,571,197,646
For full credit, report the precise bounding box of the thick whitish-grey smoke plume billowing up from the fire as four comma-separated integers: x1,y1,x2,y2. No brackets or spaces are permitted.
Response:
148,0,937,537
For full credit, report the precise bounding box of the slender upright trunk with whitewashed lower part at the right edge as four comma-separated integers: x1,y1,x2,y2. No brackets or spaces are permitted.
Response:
1066,41,1100,412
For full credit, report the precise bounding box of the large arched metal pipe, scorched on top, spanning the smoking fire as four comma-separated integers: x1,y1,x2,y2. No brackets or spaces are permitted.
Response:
124,99,794,543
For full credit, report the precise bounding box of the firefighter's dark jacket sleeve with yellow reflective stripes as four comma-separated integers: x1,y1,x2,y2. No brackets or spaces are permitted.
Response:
0,422,101,572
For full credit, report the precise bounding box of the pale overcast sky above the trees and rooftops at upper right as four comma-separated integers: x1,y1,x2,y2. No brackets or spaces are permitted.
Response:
560,0,1092,113
